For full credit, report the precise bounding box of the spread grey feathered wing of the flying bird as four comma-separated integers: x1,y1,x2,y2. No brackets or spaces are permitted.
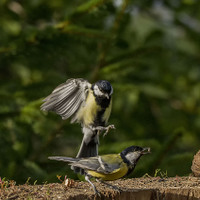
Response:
41,78,91,122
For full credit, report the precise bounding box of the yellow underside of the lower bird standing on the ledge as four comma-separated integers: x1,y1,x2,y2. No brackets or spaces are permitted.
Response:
87,163,128,181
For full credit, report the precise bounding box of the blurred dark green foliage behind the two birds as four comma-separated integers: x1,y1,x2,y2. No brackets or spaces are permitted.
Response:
0,0,200,184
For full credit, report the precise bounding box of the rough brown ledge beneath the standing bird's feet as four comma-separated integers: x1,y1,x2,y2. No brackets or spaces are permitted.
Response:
0,176,200,200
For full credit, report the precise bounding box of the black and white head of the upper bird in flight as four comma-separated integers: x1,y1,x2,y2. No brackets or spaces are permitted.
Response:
92,80,113,99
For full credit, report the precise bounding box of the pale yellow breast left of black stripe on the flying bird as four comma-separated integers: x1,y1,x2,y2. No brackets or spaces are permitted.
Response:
77,91,101,126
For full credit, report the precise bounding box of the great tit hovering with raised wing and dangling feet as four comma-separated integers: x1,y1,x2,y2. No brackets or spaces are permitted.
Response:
41,78,115,158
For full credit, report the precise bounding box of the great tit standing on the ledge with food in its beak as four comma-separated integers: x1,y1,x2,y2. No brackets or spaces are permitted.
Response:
48,146,150,193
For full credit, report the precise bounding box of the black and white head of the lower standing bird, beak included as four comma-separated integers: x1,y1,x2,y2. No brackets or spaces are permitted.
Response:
120,146,150,166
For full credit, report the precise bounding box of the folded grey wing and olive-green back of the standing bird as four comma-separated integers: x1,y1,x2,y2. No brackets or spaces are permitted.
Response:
70,154,123,174
